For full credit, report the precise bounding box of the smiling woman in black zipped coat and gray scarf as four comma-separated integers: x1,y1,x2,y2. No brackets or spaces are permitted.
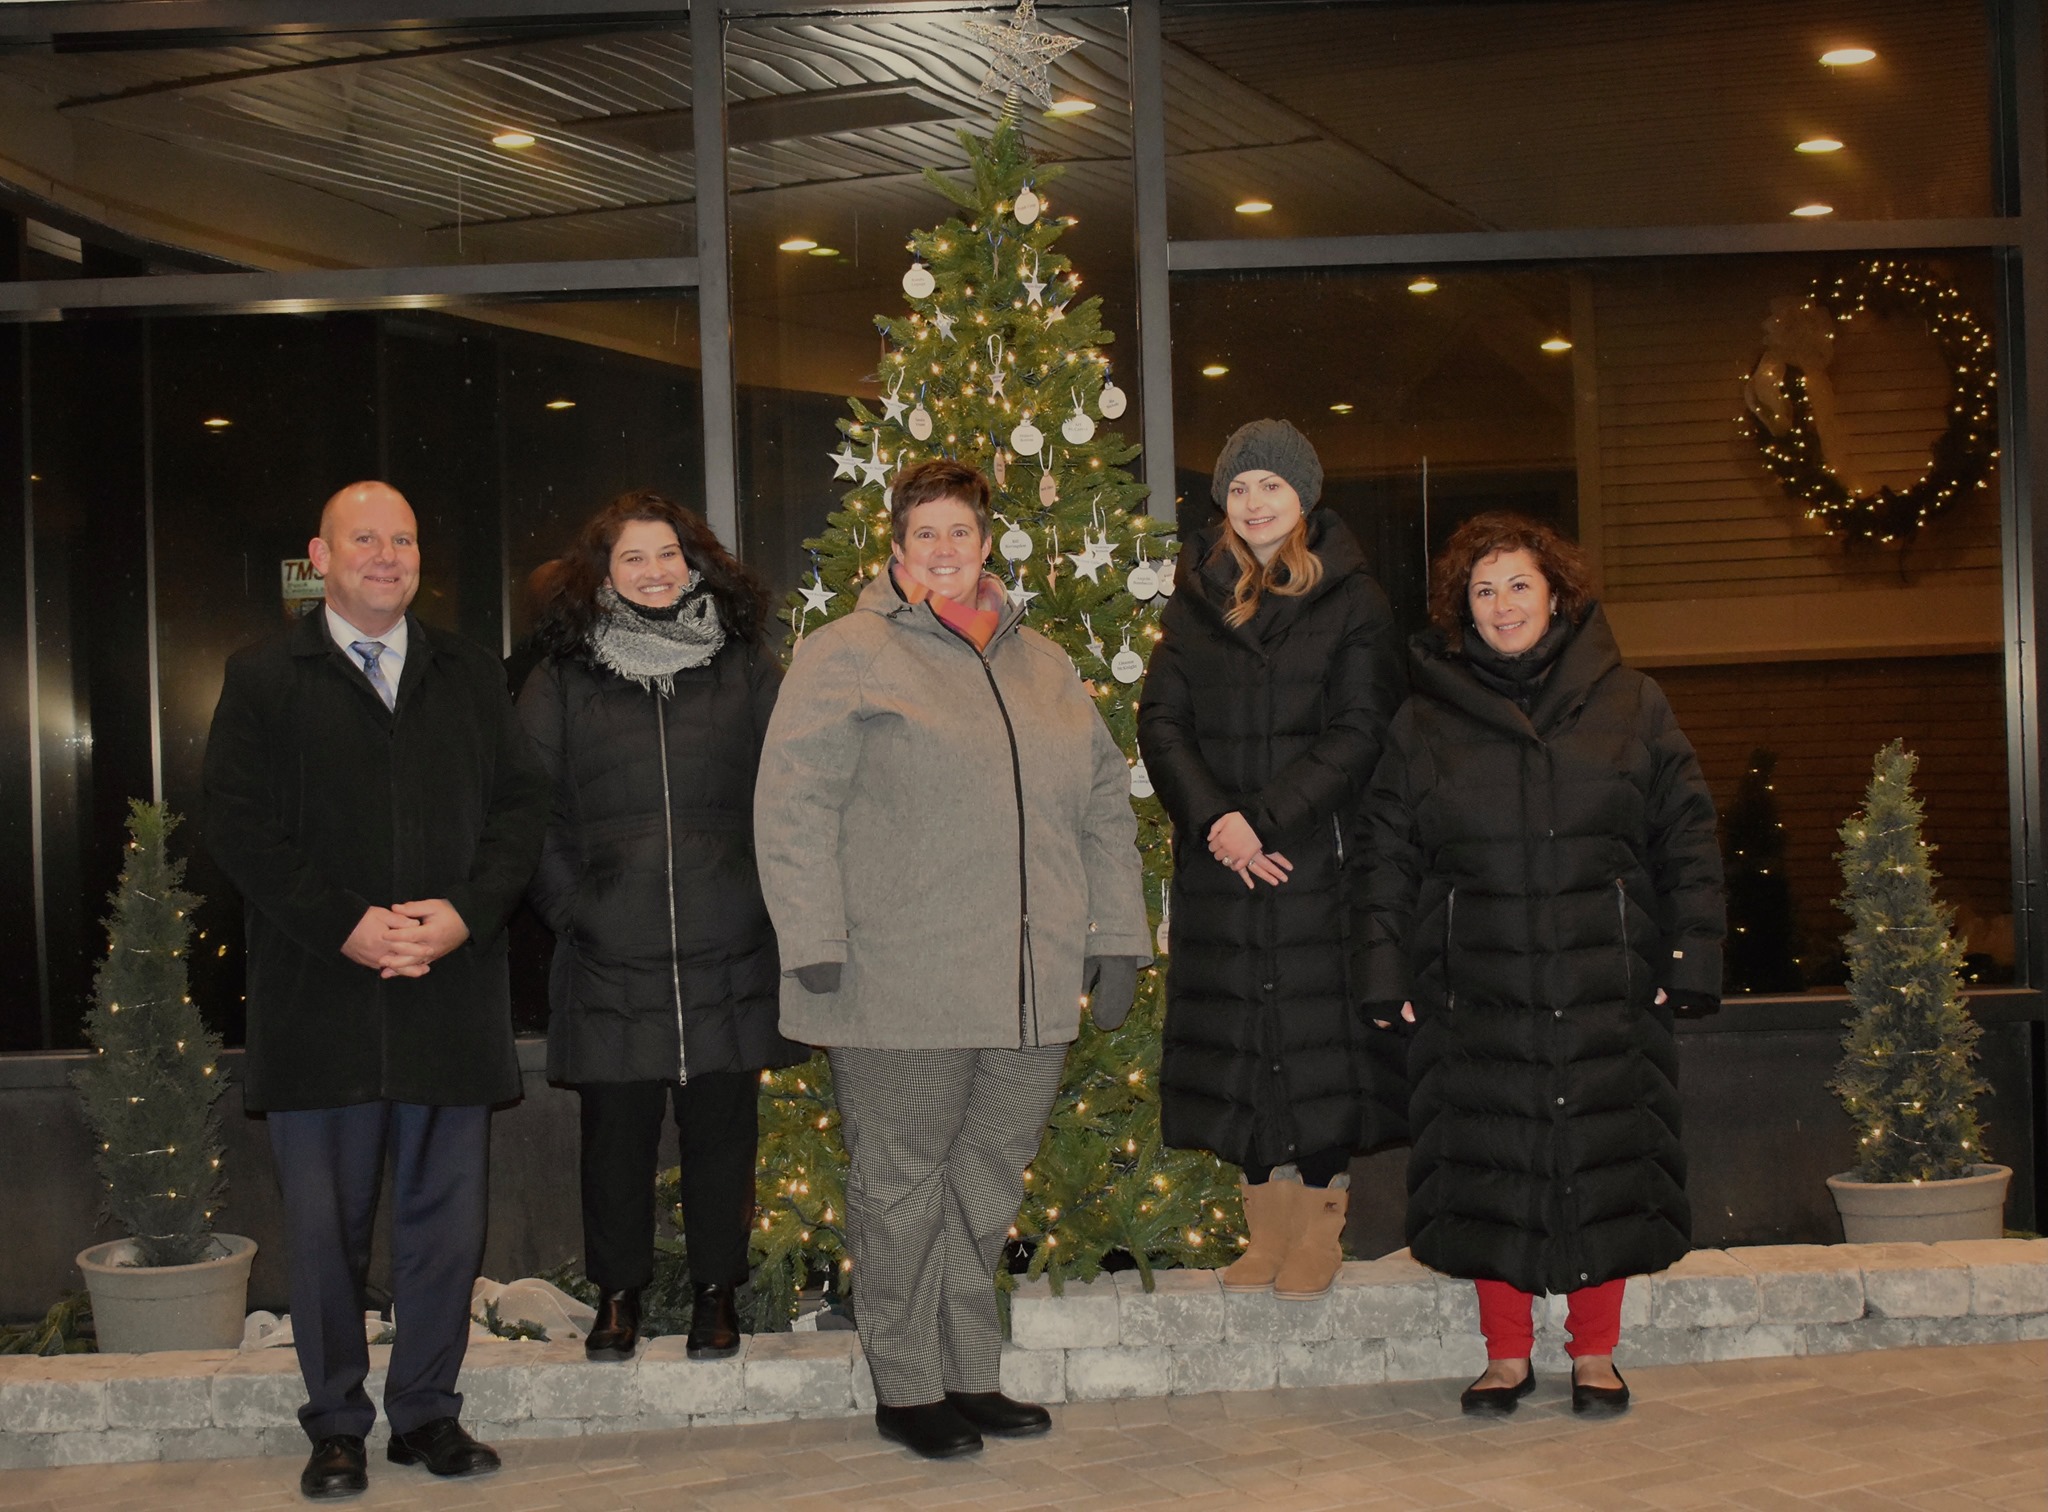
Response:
518,492,805,1360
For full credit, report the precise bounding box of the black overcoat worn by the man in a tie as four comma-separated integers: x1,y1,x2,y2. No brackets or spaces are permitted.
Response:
203,608,547,1110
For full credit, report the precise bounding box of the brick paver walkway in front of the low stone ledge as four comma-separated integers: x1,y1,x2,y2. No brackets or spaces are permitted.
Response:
0,1344,2048,1512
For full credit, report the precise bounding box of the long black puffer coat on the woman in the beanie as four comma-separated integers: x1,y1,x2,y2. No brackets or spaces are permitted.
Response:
1139,510,1405,1166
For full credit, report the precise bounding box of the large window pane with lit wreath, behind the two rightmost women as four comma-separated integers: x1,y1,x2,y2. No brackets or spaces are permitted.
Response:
1174,256,2013,990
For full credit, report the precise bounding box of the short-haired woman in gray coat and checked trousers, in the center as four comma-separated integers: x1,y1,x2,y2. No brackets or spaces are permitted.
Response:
754,461,1151,1457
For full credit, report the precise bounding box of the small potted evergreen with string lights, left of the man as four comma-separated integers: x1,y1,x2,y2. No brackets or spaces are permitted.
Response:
72,801,225,1266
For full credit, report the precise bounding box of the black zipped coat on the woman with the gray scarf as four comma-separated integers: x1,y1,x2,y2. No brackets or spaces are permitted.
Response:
518,639,809,1084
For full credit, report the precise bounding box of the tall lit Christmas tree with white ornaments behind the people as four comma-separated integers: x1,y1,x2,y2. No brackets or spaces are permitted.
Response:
754,102,1241,1324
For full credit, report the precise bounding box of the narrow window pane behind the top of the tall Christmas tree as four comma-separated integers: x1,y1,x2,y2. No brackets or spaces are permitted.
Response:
725,8,1143,594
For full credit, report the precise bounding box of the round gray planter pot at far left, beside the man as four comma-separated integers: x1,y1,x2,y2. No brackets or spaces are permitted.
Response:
78,1233,256,1354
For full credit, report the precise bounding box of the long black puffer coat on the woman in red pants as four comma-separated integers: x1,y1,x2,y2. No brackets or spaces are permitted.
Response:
1368,606,1722,1293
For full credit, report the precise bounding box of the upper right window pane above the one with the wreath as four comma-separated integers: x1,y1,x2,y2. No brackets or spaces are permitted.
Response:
1165,0,1991,240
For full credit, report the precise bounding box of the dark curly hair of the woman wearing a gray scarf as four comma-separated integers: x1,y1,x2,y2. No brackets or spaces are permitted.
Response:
530,488,768,656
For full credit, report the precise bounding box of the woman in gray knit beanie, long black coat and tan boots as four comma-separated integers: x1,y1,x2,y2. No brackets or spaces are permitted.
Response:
1139,420,1403,1297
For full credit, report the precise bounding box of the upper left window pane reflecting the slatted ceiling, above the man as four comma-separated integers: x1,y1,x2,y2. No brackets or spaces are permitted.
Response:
0,23,696,270
